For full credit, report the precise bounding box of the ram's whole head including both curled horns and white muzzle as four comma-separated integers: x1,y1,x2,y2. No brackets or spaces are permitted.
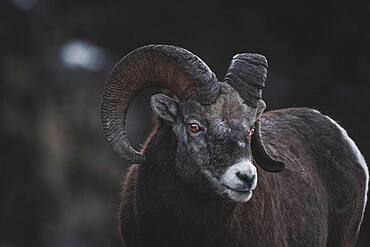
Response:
102,45,284,202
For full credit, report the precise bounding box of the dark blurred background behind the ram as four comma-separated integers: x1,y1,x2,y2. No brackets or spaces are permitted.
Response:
0,0,370,247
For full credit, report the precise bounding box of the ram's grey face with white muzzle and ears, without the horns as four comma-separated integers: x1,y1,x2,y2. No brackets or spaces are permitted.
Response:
152,84,265,202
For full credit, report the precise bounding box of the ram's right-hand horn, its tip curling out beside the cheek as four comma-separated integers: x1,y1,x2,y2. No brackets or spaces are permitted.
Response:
225,53,285,172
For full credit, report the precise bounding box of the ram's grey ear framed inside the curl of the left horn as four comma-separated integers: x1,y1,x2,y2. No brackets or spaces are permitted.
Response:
150,94,179,123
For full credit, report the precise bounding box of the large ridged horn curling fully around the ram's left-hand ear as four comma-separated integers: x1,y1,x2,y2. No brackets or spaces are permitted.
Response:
101,45,219,162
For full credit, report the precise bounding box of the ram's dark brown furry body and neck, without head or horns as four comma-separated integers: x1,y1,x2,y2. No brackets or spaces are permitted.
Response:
120,107,368,247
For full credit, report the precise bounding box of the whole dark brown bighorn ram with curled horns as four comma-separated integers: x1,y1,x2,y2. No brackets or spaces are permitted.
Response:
102,45,369,247
